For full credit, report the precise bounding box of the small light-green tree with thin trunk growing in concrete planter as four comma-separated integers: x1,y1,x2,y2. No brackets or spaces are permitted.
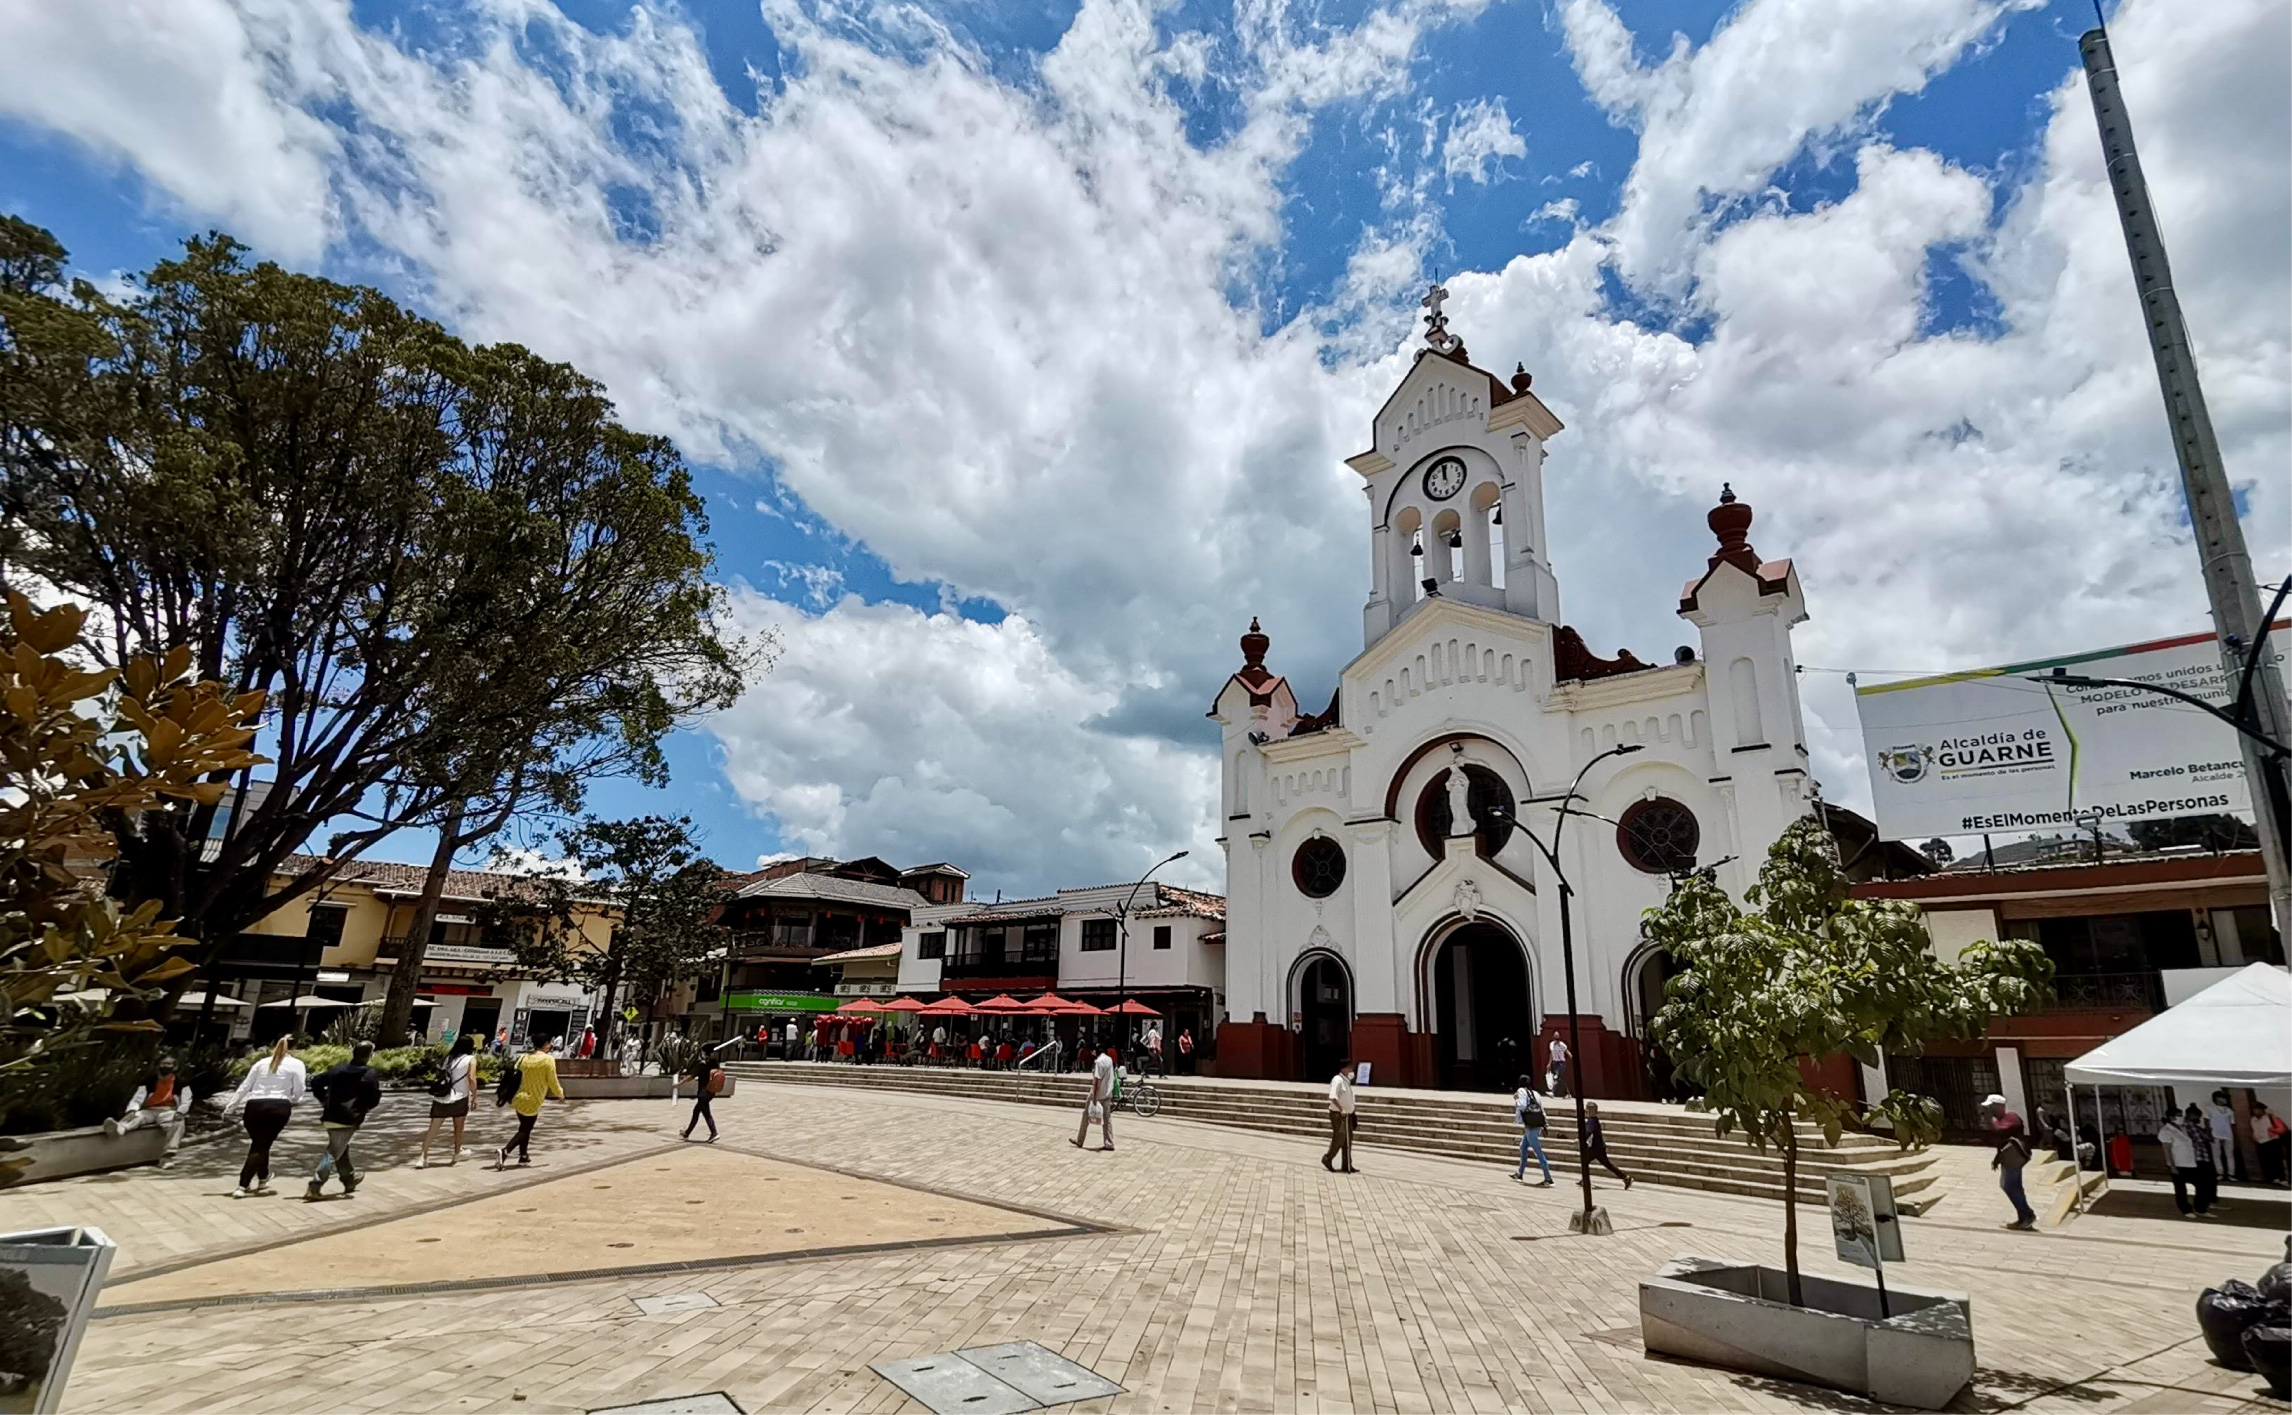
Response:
1643,816,2054,1305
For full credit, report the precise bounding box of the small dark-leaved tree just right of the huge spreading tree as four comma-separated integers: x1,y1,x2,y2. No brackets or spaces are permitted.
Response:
486,816,731,1016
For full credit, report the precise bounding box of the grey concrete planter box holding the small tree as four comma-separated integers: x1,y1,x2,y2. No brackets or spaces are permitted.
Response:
1639,1257,1973,1410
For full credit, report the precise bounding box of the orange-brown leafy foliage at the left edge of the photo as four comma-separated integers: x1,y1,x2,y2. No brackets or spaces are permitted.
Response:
0,594,261,1073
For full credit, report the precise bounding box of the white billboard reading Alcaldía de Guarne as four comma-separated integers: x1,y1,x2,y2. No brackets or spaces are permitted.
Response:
1854,624,2287,839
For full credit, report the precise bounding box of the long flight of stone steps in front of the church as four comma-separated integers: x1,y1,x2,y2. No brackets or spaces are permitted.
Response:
729,1062,1941,1213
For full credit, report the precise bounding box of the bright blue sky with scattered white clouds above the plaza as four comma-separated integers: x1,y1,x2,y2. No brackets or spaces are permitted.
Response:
0,0,2292,892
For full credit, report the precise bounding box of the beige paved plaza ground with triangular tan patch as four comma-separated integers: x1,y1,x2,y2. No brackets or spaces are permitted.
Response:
0,1082,2285,1415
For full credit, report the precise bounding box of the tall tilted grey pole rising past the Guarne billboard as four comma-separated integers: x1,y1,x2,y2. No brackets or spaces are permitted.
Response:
2077,28,2292,933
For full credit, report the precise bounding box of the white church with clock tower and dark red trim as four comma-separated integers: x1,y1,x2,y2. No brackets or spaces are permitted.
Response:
1210,287,1813,1096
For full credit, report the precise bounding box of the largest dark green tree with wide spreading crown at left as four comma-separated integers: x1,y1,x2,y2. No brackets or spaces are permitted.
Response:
0,218,749,1004
